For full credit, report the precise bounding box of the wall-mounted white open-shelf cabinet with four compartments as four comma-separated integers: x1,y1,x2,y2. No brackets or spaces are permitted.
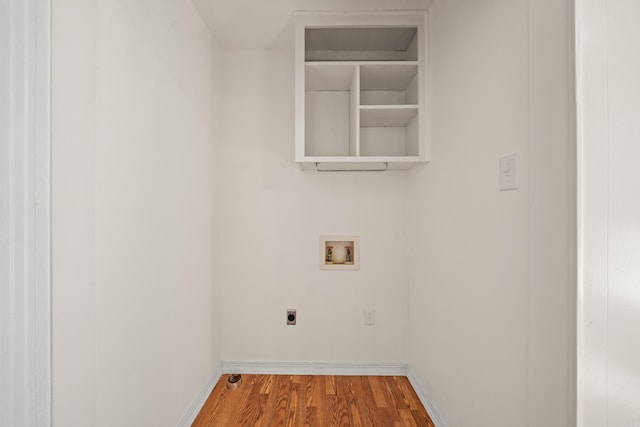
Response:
295,12,428,170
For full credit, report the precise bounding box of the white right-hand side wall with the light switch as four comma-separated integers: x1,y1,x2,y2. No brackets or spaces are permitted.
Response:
408,0,575,427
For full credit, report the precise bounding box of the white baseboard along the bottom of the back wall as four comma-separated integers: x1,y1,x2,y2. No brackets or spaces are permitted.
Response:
222,360,407,376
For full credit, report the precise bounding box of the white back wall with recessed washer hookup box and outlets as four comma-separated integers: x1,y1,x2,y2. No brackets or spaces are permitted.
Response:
220,50,408,362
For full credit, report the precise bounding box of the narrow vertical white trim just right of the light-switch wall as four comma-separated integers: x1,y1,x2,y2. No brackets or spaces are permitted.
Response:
575,0,609,427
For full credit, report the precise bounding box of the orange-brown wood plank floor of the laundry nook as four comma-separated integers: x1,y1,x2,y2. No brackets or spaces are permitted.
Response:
192,374,435,427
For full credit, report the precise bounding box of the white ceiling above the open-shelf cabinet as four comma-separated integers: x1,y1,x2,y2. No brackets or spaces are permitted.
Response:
188,0,433,49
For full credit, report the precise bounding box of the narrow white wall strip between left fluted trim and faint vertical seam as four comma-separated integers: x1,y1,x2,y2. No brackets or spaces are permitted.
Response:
51,0,96,427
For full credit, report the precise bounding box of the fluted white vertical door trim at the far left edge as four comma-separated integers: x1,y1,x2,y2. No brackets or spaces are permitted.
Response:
0,0,52,426
